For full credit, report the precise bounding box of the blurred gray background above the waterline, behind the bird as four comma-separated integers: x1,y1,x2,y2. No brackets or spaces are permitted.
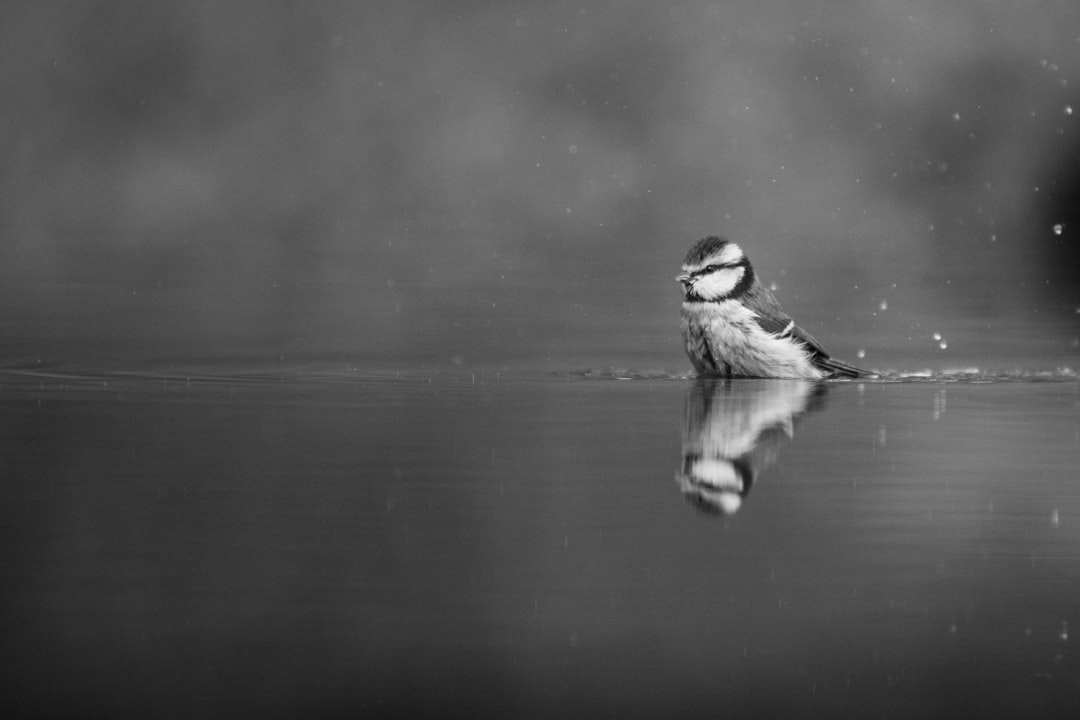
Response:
0,0,1080,371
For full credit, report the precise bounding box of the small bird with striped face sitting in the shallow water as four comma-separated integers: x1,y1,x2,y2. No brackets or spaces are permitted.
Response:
675,235,873,380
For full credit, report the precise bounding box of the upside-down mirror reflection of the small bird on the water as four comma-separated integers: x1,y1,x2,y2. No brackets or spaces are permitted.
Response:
675,378,826,515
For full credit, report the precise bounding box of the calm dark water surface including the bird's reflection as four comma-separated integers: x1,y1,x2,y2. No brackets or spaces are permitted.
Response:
0,368,1080,718
